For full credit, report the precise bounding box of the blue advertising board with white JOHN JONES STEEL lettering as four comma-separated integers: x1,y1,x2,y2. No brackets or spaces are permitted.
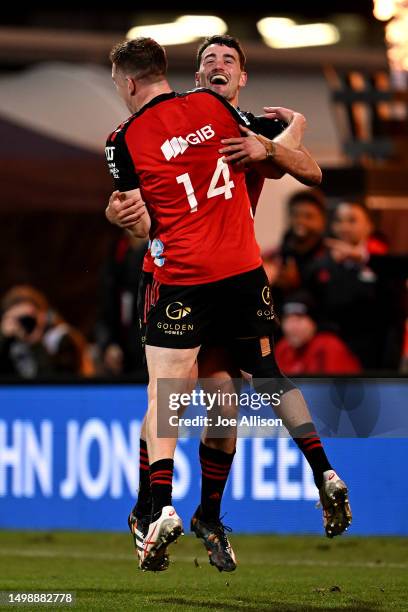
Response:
0,381,408,535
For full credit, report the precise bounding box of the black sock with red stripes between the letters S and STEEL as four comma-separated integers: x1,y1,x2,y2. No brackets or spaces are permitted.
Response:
199,442,235,522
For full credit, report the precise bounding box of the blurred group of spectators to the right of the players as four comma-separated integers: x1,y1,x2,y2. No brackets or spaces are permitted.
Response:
264,190,408,374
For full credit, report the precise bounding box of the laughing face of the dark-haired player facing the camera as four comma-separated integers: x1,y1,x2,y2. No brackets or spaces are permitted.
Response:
196,44,247,106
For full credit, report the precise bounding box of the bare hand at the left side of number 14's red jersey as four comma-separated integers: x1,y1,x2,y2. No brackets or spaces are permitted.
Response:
105,189,151,238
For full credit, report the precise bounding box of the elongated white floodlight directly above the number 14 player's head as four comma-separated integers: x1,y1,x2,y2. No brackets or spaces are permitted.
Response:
126,15,228,45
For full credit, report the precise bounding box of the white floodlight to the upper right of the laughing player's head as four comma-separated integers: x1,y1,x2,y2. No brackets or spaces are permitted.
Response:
258,20,340,49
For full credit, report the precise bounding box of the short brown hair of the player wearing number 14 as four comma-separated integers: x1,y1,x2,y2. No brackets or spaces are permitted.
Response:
109,38,167,81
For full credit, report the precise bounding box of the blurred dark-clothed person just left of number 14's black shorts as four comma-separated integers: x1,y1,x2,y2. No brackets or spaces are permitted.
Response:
95,232,147,375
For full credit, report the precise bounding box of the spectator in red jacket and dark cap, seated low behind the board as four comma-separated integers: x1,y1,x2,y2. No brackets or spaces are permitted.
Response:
276,291,361,375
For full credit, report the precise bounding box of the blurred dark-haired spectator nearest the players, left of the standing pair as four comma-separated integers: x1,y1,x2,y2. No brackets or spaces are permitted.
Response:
264,189,326,314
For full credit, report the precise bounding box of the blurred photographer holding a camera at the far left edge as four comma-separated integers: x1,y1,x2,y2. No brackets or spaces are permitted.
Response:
0,285,93,379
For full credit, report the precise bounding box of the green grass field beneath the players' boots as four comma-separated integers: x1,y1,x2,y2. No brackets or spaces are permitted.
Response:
0,531,408,612
